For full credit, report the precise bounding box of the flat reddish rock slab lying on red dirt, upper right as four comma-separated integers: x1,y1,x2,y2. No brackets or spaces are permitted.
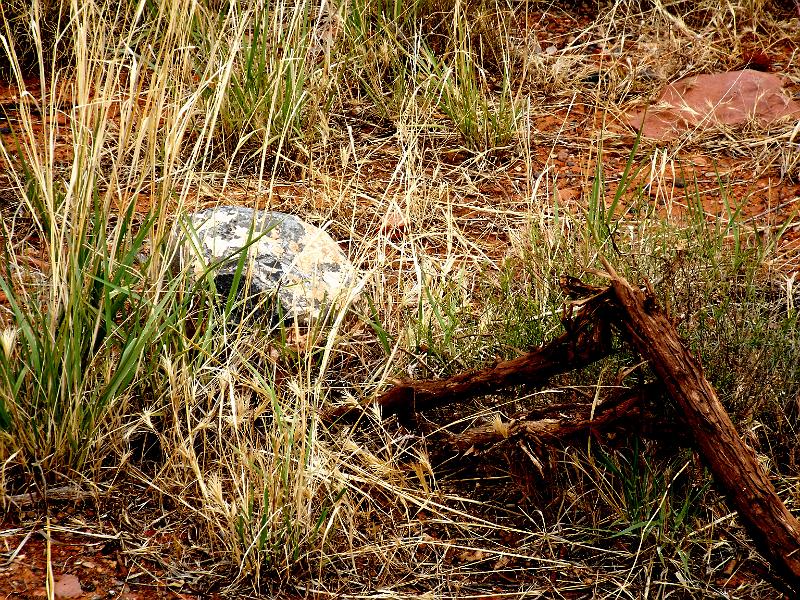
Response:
628,69,800,140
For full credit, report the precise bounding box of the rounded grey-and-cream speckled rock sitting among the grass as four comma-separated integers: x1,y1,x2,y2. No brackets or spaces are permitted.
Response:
173,206,356,323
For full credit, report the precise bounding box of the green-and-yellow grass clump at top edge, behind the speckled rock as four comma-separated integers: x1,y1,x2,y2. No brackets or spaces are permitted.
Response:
209,1,322,178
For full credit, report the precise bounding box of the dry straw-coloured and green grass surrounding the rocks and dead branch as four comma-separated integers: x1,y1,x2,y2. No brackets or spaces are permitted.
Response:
0,0,800,598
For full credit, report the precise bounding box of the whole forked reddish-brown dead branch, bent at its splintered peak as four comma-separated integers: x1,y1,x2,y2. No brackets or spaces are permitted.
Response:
327,262,800,594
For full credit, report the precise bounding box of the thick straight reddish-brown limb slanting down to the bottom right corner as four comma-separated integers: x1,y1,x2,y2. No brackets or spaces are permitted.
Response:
604,263,800,591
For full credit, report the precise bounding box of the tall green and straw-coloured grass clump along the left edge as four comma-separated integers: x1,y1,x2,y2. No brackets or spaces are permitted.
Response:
0,4,181,472
